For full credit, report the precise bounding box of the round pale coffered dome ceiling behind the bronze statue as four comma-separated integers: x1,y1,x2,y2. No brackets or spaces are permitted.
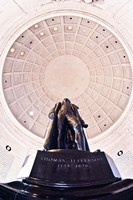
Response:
3,16,132,138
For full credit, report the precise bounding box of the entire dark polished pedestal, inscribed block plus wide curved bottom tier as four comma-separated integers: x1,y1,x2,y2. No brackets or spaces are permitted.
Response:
0,150,133,200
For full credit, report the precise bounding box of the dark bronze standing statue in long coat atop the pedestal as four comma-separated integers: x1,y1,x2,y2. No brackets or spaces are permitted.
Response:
44,98,89,151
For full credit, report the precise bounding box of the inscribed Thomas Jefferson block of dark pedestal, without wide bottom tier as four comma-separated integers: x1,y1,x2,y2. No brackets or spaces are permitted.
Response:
24,150,120,188
